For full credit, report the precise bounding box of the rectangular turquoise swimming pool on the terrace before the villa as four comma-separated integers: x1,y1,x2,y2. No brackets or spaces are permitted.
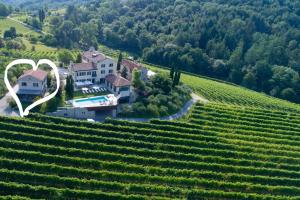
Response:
72,96,111,108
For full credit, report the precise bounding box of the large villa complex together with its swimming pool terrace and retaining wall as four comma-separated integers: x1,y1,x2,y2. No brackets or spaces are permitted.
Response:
55,49,152,119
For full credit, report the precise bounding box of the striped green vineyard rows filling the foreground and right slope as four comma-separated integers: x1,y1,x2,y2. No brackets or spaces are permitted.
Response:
0,68,300,199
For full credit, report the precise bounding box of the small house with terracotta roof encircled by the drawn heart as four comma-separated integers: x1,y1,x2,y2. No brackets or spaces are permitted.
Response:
17,69,47,101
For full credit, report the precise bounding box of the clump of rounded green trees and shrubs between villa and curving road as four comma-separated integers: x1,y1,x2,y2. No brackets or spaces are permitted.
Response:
120,70,191,117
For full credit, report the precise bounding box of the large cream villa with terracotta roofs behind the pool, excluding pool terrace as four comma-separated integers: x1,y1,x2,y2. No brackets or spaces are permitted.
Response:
69,49,139,101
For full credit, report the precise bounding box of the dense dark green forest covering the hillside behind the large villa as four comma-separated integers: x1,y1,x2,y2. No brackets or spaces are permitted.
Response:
1,0,300,102
